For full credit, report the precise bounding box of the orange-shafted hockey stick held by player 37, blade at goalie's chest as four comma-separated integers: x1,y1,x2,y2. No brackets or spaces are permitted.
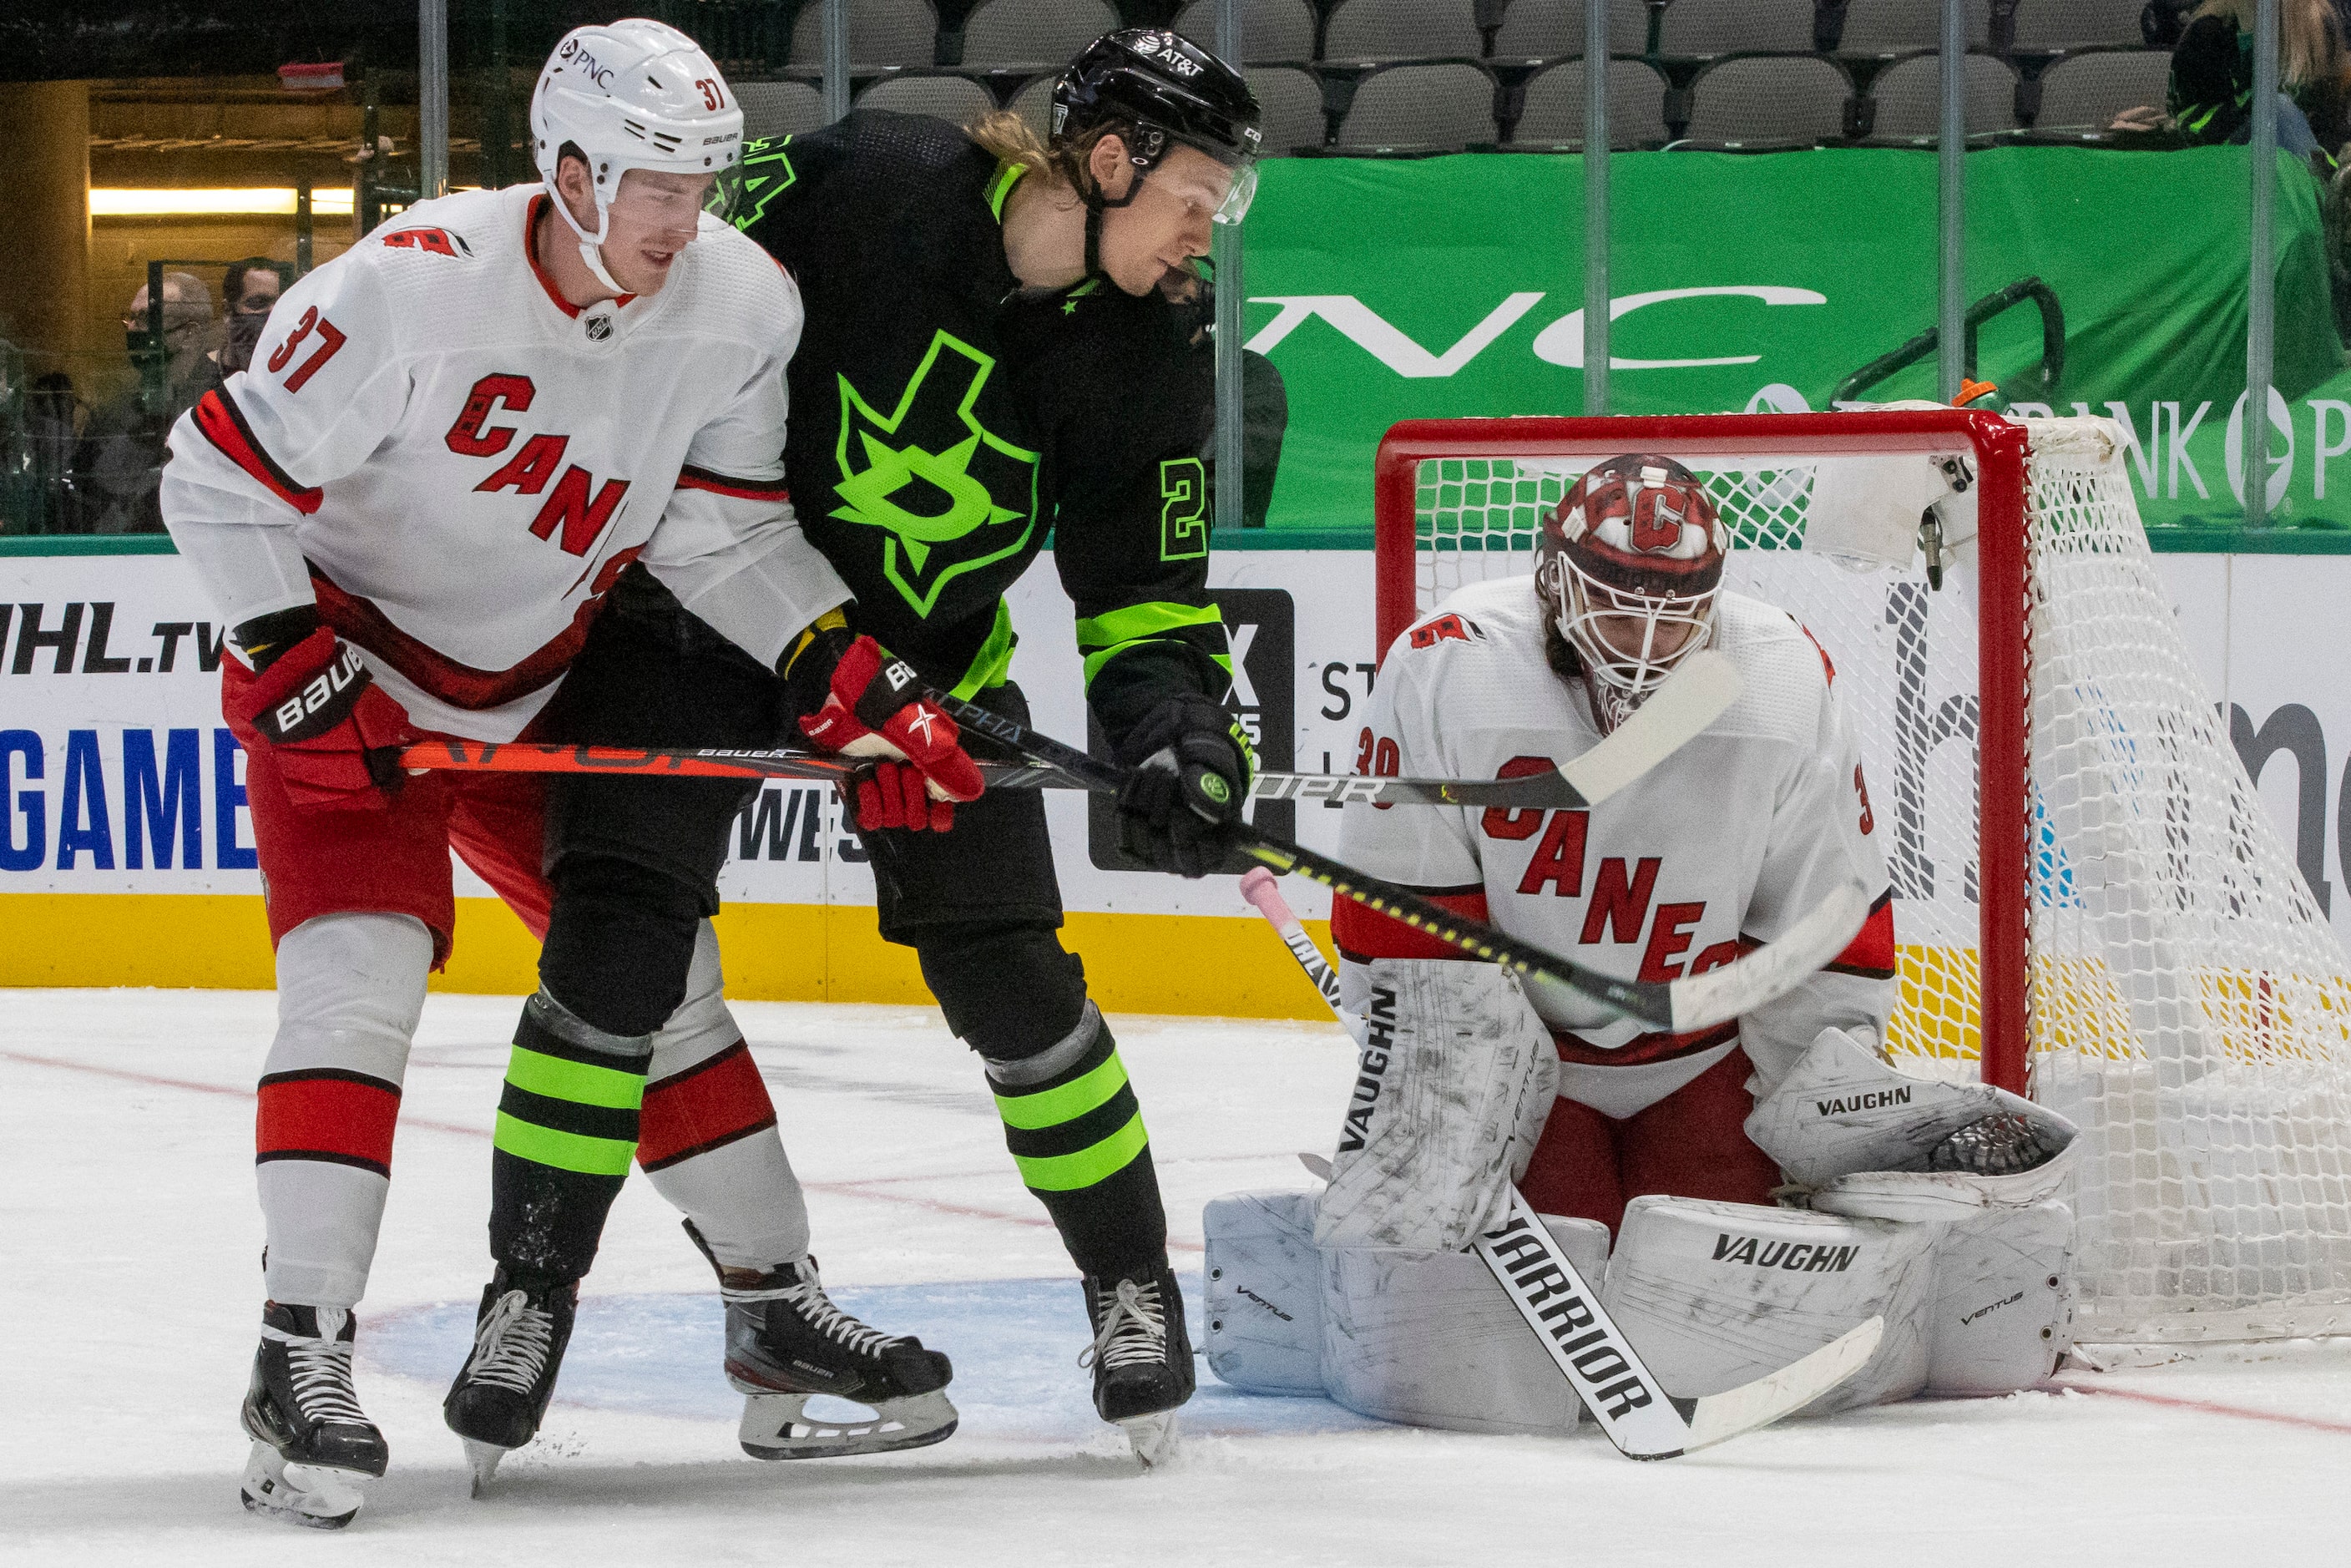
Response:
400,649,1740,811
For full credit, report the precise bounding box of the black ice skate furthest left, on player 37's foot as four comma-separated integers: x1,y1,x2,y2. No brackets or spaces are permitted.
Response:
240,1302,390,1530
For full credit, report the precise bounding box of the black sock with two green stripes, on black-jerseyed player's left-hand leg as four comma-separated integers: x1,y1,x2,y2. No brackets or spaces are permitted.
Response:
489,992,654,1279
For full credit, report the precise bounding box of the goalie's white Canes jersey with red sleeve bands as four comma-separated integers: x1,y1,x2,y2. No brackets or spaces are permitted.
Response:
1331,576,1895,1116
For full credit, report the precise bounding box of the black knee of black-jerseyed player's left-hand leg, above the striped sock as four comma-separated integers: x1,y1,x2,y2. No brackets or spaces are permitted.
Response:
538,853,705,1037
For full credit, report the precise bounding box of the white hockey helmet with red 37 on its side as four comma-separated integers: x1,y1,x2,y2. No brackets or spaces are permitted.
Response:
531,17,743,289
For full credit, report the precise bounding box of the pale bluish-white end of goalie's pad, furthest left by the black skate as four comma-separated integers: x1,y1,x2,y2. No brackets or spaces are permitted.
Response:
1201,1192,1323,1394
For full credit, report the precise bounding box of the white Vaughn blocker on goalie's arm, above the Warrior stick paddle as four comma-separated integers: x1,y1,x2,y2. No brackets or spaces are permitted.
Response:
1314,959,1559,1253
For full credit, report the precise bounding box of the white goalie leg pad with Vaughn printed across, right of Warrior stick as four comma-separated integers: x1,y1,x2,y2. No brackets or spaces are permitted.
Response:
1601,1196,1937,1415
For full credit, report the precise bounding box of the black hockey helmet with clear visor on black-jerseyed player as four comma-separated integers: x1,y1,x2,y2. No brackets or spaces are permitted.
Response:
1051,28,1260,223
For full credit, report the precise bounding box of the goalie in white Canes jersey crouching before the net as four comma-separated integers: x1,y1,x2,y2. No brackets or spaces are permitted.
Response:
1208,453,2074,1432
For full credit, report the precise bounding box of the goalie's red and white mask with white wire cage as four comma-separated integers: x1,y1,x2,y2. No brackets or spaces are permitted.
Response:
1535,453,1731,733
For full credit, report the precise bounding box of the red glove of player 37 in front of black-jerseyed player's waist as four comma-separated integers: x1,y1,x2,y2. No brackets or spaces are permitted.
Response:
799,637,980,832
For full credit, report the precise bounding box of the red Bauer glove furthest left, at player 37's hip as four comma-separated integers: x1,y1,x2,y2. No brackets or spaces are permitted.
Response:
221,628,421,811
